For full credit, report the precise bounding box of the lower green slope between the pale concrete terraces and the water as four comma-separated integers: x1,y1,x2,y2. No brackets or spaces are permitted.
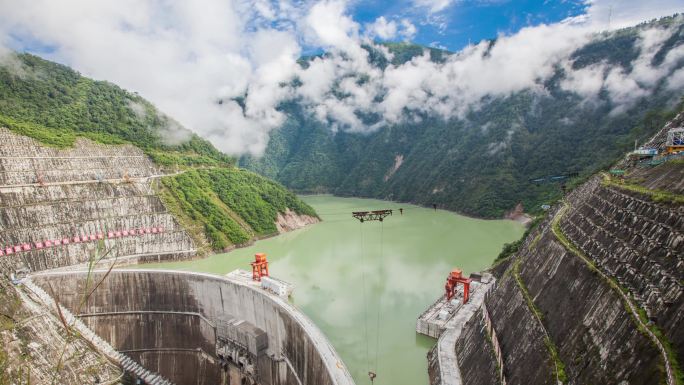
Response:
161,168,316,251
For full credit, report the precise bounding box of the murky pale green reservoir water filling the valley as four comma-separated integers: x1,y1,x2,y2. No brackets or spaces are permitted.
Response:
152,195,524,385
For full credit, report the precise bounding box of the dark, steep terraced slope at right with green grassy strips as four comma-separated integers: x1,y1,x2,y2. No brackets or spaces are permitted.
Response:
431,115,684,385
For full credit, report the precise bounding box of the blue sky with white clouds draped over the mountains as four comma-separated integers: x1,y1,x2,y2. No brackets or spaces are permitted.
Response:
0,0,684,154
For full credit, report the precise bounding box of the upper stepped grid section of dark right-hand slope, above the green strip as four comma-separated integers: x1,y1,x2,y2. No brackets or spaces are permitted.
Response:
560,178,684,357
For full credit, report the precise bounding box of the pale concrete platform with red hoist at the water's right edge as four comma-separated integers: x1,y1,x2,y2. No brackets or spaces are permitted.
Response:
416,274,493,338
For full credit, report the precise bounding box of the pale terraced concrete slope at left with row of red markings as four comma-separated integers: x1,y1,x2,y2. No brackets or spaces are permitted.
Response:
0,128,195,271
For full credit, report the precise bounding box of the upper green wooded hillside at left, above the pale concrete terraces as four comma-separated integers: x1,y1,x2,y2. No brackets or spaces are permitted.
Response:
0,54,234,165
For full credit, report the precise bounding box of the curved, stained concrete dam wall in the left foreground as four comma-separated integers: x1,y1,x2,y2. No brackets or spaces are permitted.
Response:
32,269,354,385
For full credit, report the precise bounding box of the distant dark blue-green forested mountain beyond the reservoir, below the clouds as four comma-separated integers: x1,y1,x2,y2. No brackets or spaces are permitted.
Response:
241,17,684,217
